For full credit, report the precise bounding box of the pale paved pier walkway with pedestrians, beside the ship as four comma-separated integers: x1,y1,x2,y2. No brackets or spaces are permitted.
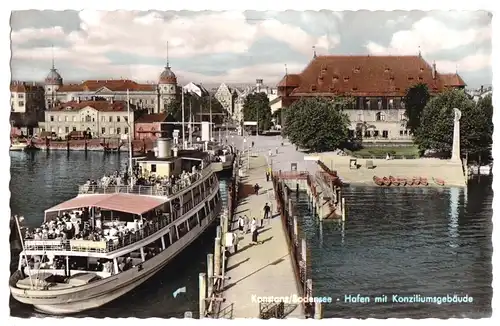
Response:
223,147,304,318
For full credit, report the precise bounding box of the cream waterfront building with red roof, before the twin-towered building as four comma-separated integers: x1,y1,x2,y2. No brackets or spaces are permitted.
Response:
40,100,135,138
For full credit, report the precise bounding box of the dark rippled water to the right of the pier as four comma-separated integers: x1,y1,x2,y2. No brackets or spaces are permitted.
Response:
299,178,493,318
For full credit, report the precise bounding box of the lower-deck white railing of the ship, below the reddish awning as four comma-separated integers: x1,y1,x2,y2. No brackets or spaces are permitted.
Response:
24,182,218,253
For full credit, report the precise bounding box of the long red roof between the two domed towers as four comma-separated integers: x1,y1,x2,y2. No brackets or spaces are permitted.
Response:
57,79,156,92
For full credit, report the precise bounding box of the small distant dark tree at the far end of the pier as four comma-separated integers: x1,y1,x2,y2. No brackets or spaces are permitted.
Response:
243,93,272,131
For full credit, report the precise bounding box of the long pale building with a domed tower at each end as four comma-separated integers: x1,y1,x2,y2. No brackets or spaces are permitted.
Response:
44,62,180,113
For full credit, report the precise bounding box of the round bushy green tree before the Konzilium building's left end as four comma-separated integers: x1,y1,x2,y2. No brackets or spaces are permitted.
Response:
283,97,354,152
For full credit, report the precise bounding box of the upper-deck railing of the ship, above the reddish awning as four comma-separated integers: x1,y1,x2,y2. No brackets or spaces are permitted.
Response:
78,169,210,196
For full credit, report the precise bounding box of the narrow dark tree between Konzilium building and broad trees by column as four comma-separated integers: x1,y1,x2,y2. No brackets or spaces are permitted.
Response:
404,83,431,133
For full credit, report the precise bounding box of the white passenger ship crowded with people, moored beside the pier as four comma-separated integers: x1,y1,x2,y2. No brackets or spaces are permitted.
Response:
9,139,221,315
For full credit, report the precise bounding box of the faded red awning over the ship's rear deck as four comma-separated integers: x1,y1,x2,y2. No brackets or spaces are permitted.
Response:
45,193,167,215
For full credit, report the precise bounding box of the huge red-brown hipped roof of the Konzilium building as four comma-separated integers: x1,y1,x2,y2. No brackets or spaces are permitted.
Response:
278,55,465,96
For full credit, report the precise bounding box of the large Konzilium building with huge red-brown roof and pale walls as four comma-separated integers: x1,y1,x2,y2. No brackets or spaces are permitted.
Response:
278,55,466,141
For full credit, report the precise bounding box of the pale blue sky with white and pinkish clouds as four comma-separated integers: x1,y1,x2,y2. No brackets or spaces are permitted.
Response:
7,10,492,88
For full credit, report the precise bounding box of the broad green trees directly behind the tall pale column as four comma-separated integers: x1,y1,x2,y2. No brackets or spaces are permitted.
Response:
414,89,493,158
